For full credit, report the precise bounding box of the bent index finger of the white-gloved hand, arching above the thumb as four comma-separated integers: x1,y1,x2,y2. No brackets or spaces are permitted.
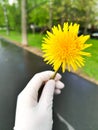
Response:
19,71,61,105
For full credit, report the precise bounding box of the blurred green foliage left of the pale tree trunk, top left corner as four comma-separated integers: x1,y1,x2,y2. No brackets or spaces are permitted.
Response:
0,0,21,31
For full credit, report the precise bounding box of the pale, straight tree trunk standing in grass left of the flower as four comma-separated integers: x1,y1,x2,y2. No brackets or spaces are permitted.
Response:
21,0,28,46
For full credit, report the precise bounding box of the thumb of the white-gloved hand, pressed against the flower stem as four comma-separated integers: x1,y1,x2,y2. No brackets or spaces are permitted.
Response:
39,80,55,109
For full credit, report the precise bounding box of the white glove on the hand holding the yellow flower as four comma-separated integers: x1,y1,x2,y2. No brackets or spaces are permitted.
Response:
14,71,64,130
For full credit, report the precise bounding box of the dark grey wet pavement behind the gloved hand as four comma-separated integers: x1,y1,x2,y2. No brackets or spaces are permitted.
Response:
0,39,98,130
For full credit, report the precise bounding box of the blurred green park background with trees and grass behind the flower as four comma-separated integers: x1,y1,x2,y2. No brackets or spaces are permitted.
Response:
0,0,98,80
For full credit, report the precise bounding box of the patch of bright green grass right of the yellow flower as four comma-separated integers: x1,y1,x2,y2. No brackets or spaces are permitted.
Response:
82,39,98,80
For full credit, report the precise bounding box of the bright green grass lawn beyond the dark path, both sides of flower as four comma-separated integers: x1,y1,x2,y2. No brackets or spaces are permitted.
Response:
0,31,98,80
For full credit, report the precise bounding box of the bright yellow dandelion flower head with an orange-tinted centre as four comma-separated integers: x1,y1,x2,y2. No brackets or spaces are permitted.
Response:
42,23,92,72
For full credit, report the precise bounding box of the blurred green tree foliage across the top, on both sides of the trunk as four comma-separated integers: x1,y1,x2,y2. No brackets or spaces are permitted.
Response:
0,0,98,31
